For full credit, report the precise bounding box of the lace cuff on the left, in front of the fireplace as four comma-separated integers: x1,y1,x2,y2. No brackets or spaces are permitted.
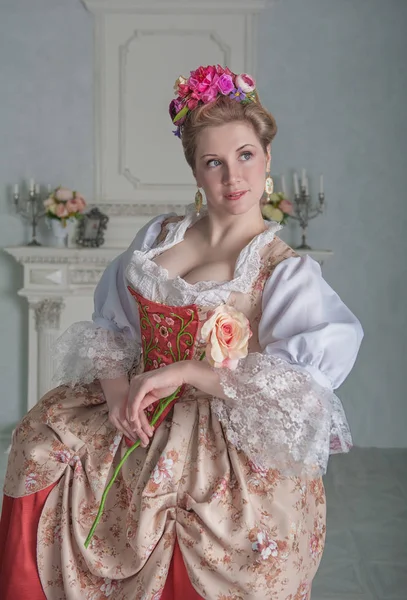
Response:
52,321,140,386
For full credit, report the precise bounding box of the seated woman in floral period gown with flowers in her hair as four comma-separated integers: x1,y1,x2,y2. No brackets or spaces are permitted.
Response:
0,65,363,600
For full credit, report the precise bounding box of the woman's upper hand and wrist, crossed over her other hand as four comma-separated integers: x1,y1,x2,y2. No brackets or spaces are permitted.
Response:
126,361,191,446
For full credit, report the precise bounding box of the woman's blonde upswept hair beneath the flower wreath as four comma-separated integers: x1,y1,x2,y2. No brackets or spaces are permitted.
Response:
181,92,277,172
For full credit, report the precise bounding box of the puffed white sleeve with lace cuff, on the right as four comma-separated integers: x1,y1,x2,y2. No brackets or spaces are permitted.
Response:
212,256,363,477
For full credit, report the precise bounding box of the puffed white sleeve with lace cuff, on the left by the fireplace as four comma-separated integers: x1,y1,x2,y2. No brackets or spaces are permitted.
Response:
53,213,173,386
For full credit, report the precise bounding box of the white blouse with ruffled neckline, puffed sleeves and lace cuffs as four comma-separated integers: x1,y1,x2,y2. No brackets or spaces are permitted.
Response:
55,205,363,474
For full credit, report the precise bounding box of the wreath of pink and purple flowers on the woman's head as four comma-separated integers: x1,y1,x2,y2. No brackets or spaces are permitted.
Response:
169,65,258,138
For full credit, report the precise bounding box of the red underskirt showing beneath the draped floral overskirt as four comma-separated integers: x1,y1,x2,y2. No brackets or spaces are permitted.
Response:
0,484,202,600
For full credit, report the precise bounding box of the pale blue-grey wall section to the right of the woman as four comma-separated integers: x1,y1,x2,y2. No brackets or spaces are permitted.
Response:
258,0,407,447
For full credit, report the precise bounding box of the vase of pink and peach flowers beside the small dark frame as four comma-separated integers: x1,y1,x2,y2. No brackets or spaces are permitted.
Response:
44,186,86,248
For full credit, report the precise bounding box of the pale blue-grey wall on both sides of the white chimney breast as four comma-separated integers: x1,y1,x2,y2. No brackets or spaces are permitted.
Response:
0,0,407,447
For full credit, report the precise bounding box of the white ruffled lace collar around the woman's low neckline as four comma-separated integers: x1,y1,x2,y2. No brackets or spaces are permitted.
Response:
126,204,282,303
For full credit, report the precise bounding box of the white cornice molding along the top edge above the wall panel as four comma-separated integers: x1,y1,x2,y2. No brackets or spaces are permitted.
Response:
82,0,275,14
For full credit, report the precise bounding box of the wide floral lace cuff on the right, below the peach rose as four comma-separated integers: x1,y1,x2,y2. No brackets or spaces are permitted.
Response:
211,352,352,477
